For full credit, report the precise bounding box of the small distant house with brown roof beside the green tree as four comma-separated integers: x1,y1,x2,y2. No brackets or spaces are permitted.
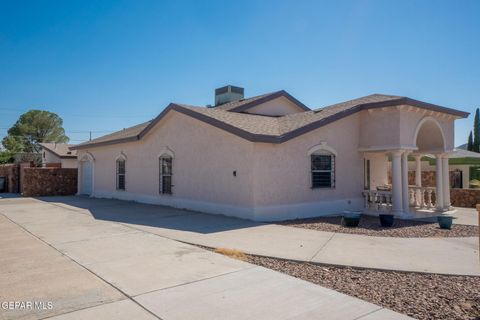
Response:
40,143,77,168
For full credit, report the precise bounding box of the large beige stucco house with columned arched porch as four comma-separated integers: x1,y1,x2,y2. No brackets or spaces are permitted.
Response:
72,86,468,221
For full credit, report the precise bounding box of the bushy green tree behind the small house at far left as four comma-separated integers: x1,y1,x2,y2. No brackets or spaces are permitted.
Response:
2,110,69,153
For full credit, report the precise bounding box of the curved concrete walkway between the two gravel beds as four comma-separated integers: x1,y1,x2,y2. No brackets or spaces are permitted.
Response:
34,197,480,276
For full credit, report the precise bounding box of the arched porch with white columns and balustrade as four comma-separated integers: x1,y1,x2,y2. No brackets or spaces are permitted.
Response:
362,117,451,217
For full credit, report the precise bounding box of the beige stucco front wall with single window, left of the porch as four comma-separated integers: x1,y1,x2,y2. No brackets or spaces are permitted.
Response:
254,114,363,218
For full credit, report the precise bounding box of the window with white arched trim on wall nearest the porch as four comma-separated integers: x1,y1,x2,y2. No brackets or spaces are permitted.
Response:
310,151,335,189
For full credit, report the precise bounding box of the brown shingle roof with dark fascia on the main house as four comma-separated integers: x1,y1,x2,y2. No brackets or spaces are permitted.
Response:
71,91,468,149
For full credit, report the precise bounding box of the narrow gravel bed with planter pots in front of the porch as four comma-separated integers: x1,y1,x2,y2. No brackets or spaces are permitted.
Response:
277,215,478,238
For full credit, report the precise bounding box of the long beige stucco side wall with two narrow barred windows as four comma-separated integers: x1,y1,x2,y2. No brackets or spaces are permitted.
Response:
78,111,253,219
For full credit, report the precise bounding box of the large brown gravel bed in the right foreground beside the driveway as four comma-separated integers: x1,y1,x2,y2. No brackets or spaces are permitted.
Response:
247,255,480,319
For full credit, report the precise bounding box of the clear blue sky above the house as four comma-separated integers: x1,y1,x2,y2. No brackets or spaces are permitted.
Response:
0,0,480,145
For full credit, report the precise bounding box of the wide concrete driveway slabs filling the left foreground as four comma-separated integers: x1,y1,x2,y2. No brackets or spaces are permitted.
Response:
0,198,408,320
